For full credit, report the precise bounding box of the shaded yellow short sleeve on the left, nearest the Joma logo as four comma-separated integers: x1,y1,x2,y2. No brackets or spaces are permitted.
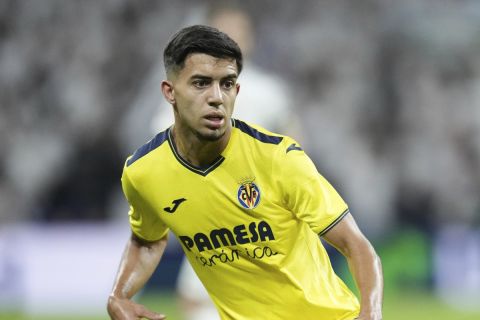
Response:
122,167,169,241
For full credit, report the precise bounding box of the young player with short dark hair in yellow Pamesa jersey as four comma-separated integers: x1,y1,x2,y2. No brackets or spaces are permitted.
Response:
108,26,383,320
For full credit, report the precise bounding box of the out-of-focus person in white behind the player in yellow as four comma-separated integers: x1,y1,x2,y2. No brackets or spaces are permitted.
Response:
169,8,299,320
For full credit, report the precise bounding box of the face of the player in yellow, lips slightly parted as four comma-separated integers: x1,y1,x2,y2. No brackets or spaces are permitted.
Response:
162,54,240,141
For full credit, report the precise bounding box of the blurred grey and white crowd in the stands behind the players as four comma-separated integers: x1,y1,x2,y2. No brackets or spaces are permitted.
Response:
0,0,480,239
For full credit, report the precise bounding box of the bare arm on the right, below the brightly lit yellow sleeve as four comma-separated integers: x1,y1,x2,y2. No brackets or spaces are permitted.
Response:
323,214,383,320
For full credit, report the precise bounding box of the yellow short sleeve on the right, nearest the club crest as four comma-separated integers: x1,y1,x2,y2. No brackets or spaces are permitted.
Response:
278,139,349,235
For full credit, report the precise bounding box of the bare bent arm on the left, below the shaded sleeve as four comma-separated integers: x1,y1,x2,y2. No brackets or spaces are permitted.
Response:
107,233,167,320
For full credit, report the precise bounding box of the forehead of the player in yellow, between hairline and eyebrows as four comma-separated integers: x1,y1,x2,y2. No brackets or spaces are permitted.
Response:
179,53,238,77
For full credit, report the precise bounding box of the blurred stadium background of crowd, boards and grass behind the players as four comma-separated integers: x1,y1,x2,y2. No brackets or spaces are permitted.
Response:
0,0,480,320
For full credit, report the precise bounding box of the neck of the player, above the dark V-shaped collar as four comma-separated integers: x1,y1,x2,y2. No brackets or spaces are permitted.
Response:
172,126,231,167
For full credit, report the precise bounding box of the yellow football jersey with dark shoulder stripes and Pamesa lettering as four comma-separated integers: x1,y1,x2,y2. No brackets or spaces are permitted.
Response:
122,119,359,320
